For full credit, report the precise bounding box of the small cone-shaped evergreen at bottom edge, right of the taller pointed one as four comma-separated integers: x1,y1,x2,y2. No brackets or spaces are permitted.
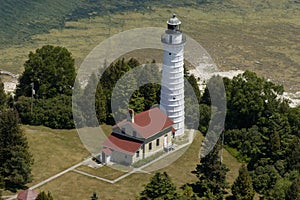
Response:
231,165,255,200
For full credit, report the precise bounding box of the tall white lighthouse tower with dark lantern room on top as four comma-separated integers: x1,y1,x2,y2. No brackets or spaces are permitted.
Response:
160,14,186,136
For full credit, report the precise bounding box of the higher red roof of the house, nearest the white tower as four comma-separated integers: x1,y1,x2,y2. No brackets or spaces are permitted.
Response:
117,107,174,138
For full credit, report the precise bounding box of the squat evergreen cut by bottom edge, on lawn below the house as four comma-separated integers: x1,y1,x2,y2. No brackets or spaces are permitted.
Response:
139,172,179,200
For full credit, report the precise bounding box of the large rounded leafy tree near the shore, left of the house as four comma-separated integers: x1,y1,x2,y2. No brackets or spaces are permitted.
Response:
16,45,76,98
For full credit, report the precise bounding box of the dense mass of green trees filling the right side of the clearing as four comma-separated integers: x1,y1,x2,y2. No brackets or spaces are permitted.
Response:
224,71,300,199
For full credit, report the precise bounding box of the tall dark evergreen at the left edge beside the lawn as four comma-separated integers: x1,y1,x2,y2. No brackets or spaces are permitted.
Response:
0,109,33,189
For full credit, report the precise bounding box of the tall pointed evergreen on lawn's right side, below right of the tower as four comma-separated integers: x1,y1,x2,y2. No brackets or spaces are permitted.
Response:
194,142,228,200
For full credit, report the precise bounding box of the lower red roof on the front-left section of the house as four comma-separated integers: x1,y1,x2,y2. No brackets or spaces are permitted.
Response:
103,133,142,154
